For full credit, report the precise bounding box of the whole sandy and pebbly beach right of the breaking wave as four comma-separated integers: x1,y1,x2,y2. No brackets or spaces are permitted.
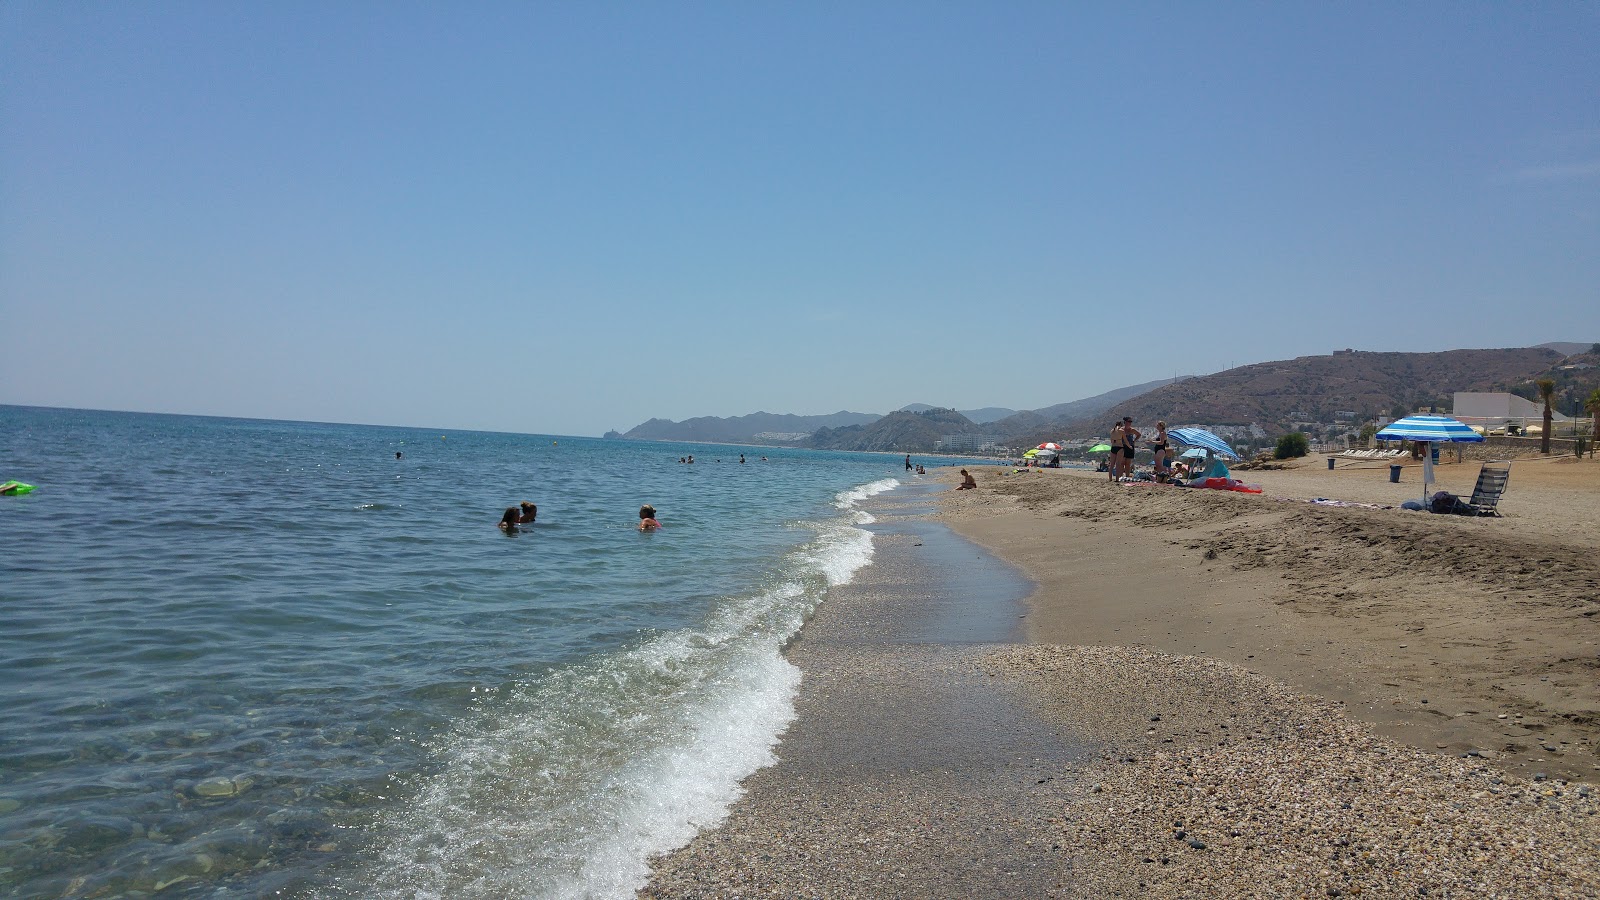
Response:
645,456,1600,897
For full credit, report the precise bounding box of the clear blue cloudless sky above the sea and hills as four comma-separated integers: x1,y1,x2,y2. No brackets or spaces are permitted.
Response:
0,0,1600,436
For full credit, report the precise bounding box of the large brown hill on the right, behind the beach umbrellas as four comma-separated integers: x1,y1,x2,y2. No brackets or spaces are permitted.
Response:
1064,348,1563,437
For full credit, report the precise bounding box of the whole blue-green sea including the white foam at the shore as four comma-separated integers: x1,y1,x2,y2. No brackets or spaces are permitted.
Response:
0,407,992,898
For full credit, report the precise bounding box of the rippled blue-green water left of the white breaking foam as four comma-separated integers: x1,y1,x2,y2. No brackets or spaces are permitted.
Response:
0,408,934,897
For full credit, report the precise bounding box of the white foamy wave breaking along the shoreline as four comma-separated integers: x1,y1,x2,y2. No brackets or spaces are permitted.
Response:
338,479,899,898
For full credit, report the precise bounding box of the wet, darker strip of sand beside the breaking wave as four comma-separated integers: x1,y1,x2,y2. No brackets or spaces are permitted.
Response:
640,480,1091,898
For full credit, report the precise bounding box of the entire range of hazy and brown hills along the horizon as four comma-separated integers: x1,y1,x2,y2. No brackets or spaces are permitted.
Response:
606,343,1600,452
